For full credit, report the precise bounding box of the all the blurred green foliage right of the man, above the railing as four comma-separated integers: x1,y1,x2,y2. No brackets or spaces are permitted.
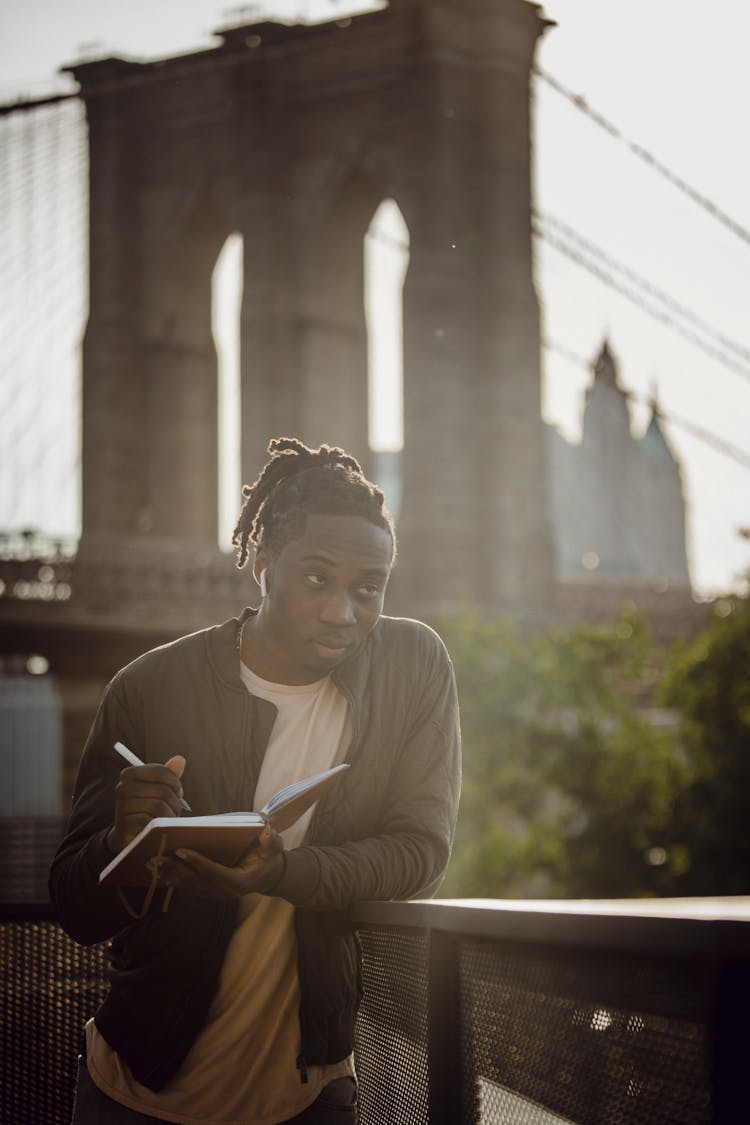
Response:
441,599,750,898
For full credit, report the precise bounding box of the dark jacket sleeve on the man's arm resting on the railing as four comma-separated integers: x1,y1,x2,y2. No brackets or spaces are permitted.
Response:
273,645,461,910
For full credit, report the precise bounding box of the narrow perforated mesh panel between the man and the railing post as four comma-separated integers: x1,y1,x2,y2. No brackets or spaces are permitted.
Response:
356,928,430,1125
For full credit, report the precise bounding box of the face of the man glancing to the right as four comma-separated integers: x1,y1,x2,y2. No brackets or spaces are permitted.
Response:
253,515,392,684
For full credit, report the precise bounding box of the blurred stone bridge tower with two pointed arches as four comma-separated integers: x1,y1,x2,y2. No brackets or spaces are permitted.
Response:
73,0,552,614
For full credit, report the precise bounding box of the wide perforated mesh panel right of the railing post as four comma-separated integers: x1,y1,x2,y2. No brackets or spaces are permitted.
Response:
459,939,713,1125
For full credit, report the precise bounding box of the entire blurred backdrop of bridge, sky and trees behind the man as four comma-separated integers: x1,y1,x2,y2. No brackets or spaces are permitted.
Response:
0,0,750,901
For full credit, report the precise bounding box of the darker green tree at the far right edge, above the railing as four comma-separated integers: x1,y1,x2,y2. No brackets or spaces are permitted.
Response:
661,599,750,894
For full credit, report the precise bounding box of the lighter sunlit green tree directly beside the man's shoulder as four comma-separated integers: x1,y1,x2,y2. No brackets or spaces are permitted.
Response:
441,613,684,898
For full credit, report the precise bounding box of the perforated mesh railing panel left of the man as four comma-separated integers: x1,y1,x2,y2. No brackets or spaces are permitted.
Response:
0,921,106,1125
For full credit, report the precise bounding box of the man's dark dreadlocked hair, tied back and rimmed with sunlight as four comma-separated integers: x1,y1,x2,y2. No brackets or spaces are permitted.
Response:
232,438,396,568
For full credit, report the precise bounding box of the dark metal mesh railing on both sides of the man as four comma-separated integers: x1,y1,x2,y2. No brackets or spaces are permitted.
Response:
0,899,750,1125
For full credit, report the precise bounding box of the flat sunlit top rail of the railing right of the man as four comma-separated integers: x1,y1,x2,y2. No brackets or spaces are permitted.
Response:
354,897,750,959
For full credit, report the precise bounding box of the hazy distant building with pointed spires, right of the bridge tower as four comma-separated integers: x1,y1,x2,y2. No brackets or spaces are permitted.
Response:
546,342,690,595
